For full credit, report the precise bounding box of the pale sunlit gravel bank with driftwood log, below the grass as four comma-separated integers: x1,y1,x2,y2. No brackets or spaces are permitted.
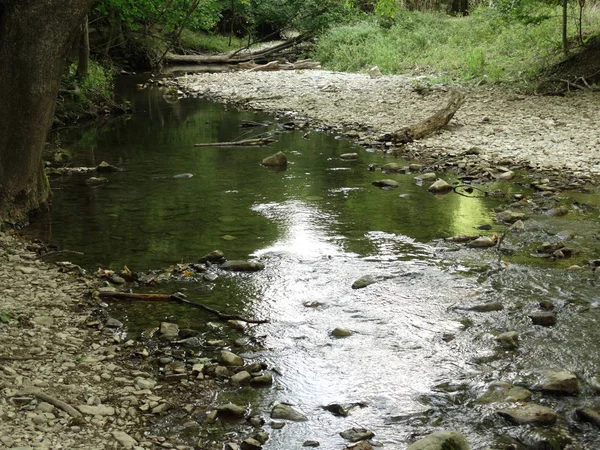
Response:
175,70,600,181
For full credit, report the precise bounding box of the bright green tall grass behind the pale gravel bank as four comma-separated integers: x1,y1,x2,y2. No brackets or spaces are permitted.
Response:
315,8,600,81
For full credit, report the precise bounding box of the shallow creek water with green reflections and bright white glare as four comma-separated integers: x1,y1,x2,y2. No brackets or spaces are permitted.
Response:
29,82,600,450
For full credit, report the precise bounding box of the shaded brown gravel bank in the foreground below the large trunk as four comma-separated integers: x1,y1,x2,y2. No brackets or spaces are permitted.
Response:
0,233,189,450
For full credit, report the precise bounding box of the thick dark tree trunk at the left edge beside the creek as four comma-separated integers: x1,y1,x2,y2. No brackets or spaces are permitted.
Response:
0,0,94,223
